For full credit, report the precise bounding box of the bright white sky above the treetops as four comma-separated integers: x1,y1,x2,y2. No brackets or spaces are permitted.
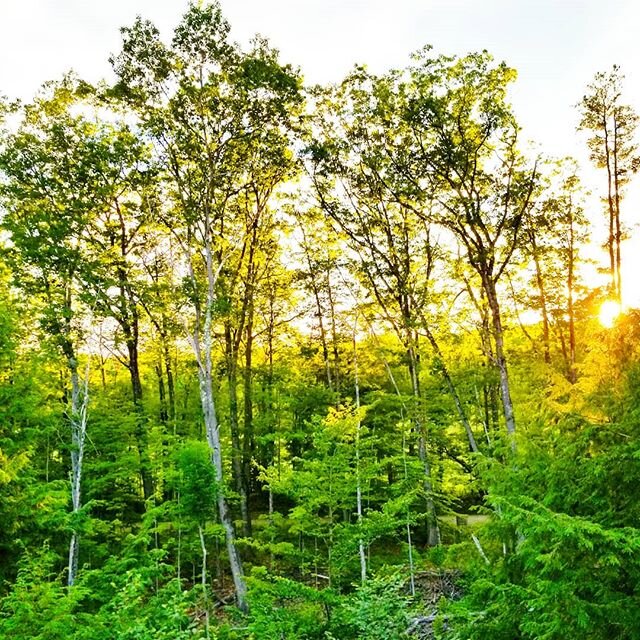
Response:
0,0,640,304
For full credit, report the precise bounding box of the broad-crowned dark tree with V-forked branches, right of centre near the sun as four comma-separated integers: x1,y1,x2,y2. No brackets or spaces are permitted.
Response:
395,49,537,435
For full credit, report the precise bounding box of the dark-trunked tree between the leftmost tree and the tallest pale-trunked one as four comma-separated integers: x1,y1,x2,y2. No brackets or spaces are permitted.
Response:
75,113,154,499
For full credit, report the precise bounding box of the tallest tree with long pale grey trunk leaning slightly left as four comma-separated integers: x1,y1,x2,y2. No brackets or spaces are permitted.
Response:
113,4,300,608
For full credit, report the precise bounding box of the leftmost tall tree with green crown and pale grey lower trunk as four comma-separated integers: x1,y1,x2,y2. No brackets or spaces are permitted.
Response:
0,77,127,586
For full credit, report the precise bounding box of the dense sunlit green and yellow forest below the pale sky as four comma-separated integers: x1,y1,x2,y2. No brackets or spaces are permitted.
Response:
0,3,640,640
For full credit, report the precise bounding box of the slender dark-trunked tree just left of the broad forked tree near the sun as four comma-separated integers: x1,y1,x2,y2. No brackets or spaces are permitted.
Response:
307,72,440,545
